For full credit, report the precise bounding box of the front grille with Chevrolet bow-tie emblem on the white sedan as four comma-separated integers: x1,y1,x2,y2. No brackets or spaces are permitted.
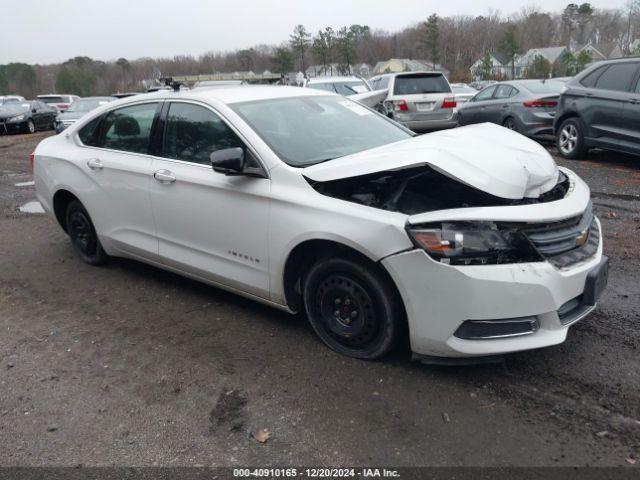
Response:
524,204,600,267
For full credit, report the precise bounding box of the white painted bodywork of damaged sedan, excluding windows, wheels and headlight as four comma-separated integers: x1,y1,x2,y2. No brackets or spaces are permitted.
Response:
34,87,602,357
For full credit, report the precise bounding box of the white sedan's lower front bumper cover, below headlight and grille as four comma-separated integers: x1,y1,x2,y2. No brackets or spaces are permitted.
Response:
382,224,606,357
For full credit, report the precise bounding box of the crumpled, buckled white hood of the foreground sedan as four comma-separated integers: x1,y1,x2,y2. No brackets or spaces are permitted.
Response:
302,123,558,199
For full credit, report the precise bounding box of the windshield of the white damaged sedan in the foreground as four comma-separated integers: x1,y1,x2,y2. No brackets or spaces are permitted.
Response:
230,96,412,167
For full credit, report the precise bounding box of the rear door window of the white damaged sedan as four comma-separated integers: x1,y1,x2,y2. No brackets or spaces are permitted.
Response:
98,103,158,153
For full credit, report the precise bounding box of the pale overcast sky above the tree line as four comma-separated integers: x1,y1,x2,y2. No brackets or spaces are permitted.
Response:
0,0,625,64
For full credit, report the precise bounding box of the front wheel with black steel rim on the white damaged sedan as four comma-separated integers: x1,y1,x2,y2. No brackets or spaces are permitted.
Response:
303,257,405,360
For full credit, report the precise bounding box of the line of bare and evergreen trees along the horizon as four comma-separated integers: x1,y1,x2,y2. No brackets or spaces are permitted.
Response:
0,0,640,97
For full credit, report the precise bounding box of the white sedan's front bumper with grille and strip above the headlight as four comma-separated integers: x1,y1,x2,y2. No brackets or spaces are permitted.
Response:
381,170,608,357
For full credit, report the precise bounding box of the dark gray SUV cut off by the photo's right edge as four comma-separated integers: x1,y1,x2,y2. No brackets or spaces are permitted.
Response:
554,58,640,158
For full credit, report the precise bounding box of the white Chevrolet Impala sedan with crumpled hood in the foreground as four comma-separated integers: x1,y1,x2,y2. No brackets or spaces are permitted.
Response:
34,86,608,359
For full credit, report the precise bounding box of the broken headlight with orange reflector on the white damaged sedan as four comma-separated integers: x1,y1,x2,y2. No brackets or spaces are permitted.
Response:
408,222,542,265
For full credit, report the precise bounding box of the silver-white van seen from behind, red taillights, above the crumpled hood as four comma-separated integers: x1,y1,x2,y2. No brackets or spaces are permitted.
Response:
369,72,458,131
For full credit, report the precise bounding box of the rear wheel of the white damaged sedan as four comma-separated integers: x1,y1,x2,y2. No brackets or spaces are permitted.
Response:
65,200,109,265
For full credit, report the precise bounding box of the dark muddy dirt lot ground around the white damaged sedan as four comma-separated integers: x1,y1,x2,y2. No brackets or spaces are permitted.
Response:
0,130,640,468
